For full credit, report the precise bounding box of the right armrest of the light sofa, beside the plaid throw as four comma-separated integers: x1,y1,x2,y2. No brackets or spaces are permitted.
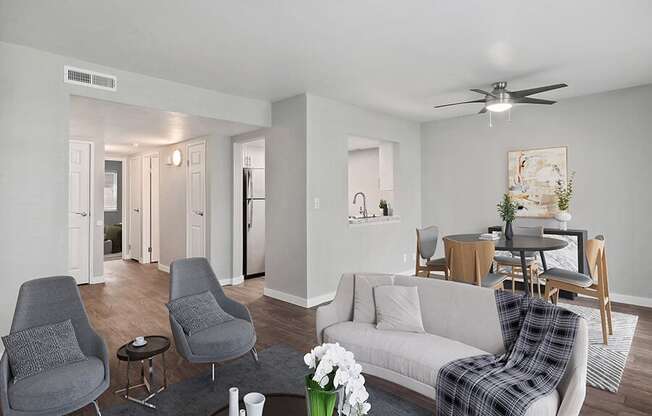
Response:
557,318,589,416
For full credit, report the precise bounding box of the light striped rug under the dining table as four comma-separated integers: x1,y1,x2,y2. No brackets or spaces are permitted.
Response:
559,303,638,393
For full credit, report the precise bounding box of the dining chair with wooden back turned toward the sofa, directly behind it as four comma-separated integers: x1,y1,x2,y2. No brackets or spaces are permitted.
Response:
444,238,507,289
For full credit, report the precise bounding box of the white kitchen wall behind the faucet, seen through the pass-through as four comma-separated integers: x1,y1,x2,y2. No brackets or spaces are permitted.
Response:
348,147,382,216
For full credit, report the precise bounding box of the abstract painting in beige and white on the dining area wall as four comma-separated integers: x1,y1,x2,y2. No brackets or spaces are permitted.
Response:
507,147,568,218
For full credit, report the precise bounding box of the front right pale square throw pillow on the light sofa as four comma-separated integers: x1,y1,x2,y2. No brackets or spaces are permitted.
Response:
374,286,426,333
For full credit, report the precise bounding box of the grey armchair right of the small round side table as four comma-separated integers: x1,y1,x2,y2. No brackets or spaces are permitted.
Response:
170,257,258,381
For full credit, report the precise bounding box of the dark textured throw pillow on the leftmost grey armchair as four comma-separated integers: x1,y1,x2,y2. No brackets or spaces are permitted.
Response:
2,319,86,383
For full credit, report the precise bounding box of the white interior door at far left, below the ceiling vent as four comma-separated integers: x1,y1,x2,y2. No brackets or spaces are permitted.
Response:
68,142,91,284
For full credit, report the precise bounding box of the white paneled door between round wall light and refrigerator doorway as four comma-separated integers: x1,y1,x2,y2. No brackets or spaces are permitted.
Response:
186,143,206,257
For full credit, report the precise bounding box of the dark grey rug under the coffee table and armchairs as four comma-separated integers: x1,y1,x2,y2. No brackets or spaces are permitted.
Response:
102,345,434,416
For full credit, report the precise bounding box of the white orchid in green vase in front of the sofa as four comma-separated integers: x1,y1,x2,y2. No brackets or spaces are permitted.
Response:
303,343,371,416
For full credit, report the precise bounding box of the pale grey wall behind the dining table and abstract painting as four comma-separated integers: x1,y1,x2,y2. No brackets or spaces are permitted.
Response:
421,85,652,300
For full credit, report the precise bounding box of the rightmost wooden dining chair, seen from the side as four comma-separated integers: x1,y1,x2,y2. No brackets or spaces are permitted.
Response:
541,235,613,345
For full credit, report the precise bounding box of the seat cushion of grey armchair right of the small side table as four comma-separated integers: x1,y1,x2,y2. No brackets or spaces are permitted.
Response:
188,319,255,356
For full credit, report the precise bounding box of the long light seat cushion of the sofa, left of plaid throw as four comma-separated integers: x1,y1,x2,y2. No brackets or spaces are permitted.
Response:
324,322,486,387
